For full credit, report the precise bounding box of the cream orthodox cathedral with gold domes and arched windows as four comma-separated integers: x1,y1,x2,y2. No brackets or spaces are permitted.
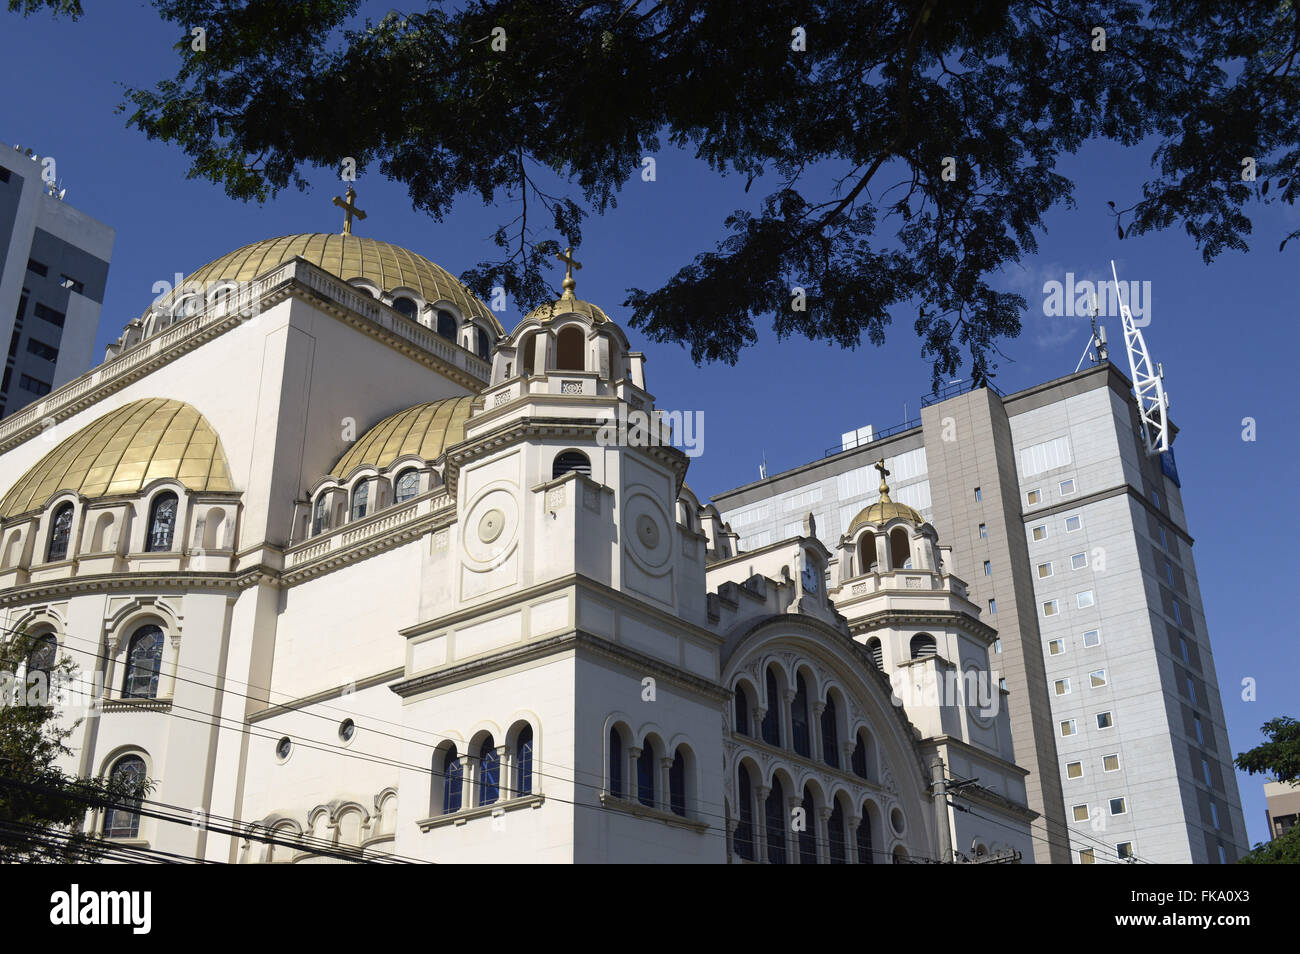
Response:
0,205,1036,864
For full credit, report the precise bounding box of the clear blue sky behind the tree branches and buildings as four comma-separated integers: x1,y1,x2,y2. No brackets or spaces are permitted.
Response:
0,1,1300,842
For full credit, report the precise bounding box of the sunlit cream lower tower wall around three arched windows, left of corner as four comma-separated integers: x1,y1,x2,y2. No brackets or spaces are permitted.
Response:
395,651,577,864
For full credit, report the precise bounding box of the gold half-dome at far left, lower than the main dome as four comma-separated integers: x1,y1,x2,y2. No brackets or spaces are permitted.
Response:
0,398,234,517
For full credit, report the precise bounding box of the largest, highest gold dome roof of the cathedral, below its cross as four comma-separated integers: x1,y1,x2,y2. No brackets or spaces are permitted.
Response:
161,233,504,334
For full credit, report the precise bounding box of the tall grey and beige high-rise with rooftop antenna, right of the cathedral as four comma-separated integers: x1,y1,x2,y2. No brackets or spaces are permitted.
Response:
714,363,1248,863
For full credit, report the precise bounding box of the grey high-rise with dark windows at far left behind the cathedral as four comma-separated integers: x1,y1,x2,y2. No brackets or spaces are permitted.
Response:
0,146,113,417
